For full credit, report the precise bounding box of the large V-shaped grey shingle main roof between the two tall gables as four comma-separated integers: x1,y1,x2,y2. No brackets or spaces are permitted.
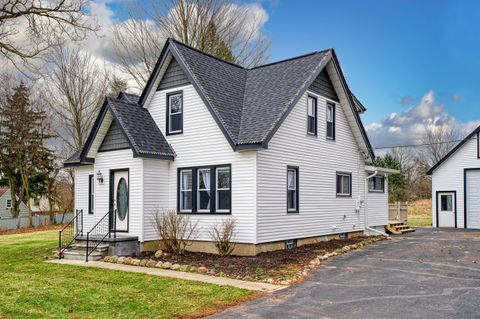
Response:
169,40,352,146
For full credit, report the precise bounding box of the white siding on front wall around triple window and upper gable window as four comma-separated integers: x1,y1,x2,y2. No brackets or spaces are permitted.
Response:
145,85,256,243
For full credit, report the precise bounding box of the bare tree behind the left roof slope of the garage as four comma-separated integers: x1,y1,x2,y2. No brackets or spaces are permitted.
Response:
421,125,462,167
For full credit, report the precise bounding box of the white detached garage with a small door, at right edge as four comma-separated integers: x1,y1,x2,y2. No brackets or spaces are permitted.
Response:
427,127,480,229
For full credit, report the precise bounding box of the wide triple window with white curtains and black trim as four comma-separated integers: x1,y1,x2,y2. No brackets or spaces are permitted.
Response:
177,165,232,213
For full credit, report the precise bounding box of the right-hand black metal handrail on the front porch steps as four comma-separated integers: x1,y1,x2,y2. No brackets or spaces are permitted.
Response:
85,209,117,262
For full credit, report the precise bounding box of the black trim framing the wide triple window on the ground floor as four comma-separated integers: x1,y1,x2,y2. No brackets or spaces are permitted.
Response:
177,164,232,215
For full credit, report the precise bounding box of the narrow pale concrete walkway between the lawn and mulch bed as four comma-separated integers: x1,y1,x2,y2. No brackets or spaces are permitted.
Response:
47,259,286,292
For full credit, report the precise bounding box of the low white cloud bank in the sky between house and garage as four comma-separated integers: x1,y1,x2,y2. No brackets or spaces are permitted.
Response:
366,90,480,147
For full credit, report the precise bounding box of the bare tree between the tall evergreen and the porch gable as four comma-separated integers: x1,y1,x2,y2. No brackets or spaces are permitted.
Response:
44,46,109,151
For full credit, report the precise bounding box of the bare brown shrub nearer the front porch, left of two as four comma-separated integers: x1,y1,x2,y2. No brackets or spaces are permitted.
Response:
153,209,197,255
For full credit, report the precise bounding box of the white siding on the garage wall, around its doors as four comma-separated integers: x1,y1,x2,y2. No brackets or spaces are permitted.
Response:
432,135,480,228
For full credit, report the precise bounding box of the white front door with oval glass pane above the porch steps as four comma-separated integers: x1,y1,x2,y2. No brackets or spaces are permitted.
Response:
110,170,129,232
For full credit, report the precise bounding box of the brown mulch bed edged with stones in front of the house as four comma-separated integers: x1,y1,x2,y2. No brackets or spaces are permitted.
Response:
146,236,382,282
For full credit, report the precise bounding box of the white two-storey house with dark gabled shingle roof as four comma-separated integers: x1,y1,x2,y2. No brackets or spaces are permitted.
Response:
65,40,398,255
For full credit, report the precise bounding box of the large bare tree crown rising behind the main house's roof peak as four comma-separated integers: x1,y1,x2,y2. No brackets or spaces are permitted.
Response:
114,0,269,88
